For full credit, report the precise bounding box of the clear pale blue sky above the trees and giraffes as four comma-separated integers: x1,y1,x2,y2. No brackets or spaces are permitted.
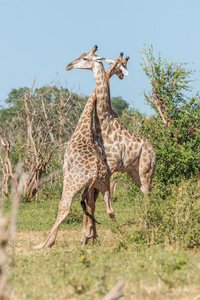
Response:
0,0,200,115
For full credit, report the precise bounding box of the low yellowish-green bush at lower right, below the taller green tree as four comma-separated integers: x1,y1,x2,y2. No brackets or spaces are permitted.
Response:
128,181,200,248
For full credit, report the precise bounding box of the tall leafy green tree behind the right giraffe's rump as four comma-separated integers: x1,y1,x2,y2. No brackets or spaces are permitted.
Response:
138,47,200,185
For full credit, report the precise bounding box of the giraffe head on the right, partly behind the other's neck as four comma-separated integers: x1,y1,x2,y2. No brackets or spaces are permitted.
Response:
105,52,130,79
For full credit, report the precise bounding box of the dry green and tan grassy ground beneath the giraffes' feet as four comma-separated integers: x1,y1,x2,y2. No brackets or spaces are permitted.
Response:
3,183,200,300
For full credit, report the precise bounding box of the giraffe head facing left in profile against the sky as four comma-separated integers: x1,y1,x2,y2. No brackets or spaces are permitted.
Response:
66,46,105,71
